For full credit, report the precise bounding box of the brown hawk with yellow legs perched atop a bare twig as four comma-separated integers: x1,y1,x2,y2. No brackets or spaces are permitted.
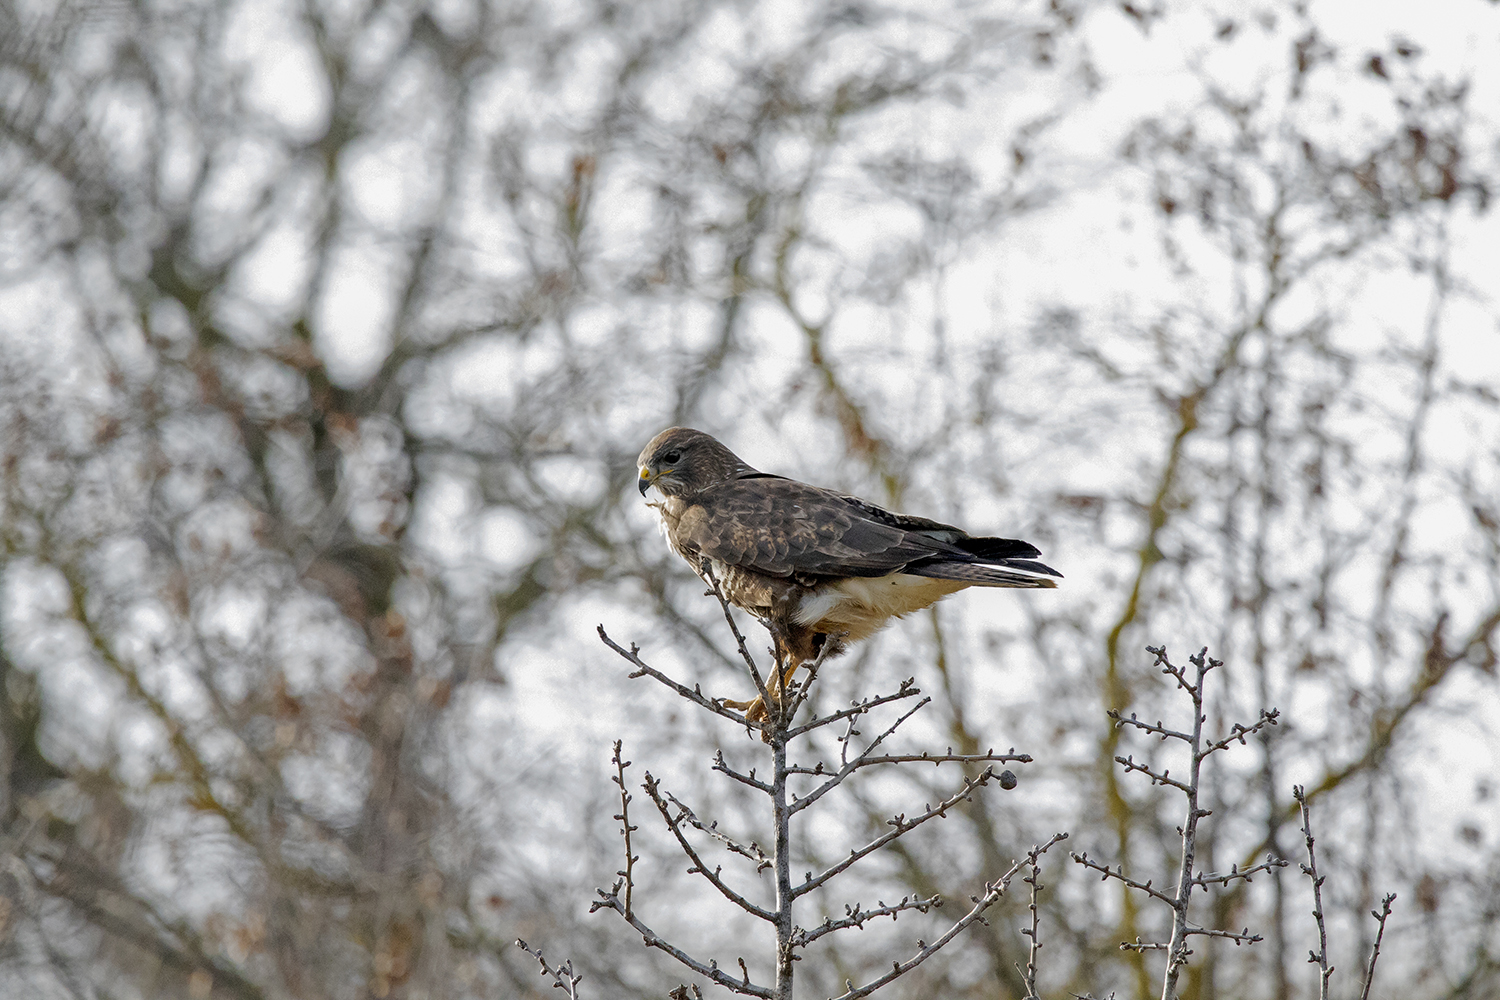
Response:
636,427,1062,721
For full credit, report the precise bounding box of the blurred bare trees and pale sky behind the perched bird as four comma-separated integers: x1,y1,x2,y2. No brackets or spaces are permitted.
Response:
0,0,1500,1000
